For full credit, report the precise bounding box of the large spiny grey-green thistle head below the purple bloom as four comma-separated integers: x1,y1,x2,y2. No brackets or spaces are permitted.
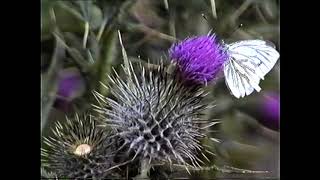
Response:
94,62,216,170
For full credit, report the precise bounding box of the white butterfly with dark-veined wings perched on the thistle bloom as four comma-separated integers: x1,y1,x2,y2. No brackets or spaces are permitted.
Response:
224,40,280,98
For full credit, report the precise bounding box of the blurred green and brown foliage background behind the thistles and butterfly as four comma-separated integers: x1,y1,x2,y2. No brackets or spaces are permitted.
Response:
41,0,280,179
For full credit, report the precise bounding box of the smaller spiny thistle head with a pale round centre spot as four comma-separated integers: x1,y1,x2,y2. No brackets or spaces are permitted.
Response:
41,114,119,179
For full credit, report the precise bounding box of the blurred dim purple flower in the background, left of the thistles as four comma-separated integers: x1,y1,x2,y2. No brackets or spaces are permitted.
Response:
55,68,85,111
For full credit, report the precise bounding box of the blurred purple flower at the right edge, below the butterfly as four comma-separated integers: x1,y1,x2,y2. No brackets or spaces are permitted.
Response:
261,93,280,130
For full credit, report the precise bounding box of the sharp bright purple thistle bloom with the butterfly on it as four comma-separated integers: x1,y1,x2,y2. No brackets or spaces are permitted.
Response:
169,35,228,84
